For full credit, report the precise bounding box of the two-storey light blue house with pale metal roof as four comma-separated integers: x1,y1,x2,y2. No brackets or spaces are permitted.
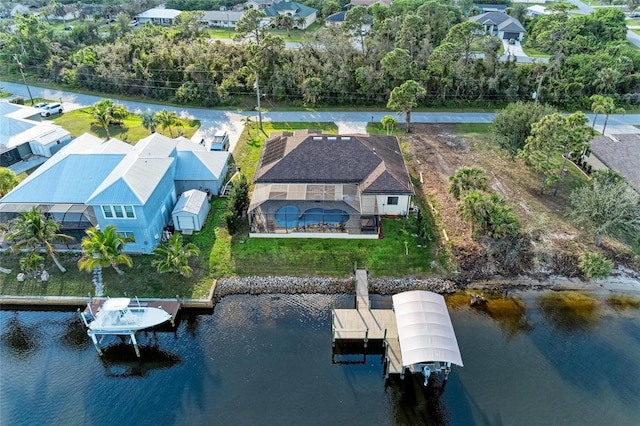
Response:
0,133,230,253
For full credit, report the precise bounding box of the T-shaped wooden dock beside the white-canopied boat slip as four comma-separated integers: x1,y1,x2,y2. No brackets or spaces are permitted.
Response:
331,269,404,377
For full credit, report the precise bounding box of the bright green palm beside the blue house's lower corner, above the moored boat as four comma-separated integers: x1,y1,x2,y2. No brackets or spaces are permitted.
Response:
78,225,133,275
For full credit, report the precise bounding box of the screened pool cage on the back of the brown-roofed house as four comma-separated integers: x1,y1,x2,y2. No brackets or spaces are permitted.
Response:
249,184,379,235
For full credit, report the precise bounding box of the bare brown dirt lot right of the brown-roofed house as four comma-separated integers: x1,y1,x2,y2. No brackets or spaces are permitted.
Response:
400,124,637,278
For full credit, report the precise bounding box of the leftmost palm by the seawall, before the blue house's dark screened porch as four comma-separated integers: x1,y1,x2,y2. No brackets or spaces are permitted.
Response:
6,207,73,272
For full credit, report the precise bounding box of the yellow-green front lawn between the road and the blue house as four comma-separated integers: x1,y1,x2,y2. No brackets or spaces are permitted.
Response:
50,108,200,144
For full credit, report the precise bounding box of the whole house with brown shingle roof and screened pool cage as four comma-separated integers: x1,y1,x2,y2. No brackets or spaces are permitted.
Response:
248,130,414,238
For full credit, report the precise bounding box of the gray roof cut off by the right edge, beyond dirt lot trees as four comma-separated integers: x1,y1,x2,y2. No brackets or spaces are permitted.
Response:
591,134,640,191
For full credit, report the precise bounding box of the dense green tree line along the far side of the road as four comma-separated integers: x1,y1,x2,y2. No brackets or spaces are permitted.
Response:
0,0,640,109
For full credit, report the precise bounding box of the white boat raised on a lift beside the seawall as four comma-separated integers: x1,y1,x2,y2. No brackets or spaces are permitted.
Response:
80,297,173,357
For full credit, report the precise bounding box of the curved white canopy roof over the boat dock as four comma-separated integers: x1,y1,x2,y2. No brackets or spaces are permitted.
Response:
393,290,462,367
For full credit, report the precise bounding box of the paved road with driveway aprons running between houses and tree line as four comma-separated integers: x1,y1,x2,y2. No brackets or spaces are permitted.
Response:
0,81,640,149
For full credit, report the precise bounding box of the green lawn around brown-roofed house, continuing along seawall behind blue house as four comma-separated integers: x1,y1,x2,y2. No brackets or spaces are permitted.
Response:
0,122,436,298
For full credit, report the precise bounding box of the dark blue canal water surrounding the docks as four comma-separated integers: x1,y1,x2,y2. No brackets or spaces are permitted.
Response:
0,293,640,426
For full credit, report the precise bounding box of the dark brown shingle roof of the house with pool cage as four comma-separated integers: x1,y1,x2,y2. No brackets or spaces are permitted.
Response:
254,131,413,194
